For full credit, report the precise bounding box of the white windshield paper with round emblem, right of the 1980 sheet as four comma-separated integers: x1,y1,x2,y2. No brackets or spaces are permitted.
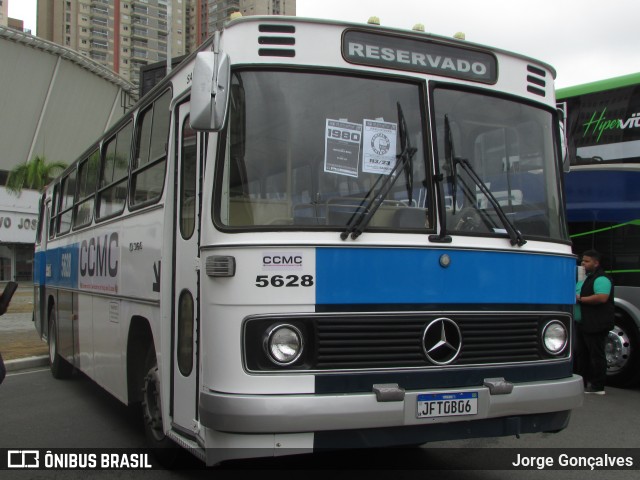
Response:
362,120,398,175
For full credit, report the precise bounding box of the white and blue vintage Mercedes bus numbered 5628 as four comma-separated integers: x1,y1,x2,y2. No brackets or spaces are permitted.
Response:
35,17,583,464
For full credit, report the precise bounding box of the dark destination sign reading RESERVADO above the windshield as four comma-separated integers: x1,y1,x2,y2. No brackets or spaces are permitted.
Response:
342,30,498,84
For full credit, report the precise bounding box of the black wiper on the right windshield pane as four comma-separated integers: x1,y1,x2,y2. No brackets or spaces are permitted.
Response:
440,115,527,247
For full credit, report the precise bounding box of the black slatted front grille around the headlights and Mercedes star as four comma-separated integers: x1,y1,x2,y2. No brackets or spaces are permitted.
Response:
245,313,570,371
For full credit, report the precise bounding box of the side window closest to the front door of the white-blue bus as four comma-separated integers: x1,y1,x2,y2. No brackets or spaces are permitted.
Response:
131,90,171,206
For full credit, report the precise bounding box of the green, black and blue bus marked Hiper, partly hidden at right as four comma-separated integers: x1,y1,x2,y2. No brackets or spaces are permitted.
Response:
556,73,640,387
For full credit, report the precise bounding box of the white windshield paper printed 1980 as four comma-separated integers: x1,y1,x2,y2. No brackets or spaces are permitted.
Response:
324,119,362,178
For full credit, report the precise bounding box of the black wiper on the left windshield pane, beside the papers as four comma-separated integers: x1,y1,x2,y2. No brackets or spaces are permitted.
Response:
340,102,418,240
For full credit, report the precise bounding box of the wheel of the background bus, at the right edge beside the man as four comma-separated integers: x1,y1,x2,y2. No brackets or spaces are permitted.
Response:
605,312,640,387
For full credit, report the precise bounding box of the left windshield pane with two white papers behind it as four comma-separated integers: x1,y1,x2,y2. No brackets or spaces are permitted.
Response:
214,71,433,231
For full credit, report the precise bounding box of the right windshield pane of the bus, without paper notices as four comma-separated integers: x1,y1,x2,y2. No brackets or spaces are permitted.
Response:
433,88,567,240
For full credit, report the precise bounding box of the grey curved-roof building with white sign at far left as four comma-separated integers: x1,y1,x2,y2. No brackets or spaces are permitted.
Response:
0,27,137,282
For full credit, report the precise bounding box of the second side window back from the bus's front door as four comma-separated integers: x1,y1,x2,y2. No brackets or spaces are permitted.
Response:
96,122,133,219
